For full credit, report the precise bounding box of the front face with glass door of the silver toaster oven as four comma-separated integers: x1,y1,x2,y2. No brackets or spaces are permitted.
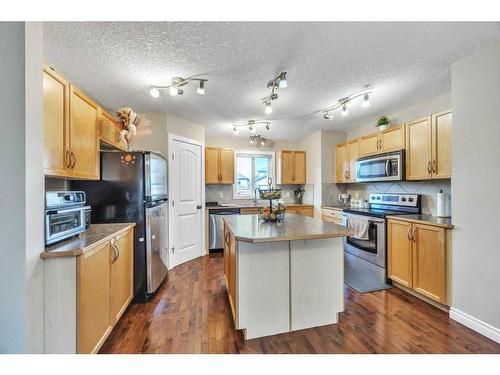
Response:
45,207,86,245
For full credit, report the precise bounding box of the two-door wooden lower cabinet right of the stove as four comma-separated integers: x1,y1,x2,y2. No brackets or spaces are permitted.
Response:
387,219,450,305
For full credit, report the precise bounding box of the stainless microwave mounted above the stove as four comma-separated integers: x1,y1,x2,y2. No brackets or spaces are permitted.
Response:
356,150,405,182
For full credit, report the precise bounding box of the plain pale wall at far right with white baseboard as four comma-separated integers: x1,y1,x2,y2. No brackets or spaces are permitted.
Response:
450,43,500,342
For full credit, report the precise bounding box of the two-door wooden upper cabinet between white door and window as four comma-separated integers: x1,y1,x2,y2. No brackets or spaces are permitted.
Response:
205,147,235,184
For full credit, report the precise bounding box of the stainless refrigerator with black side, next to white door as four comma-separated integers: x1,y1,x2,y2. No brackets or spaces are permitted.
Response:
71,151,168,302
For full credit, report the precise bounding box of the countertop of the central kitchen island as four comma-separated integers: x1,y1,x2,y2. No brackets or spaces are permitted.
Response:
223,214,353,243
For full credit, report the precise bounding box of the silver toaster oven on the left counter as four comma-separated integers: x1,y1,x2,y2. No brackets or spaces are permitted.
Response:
45,191,90,245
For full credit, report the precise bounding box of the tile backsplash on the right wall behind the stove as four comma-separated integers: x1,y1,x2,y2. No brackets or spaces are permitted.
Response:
347,180,451,215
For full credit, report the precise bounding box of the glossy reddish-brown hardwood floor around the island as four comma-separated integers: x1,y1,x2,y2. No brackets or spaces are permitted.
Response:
100,254,500,353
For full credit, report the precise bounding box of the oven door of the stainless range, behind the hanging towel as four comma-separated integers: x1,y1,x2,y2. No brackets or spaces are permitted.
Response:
342,214,386,268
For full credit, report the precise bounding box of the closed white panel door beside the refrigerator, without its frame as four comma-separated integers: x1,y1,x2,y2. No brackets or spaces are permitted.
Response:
170,139,203,267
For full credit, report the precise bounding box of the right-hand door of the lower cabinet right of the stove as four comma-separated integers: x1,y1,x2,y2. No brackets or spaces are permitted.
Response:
413,224,446,303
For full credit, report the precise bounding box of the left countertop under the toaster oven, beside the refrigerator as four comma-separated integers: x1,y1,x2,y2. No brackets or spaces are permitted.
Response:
40,223,135,259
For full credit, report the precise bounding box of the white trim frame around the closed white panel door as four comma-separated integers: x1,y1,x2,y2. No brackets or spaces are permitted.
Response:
167,133,208,270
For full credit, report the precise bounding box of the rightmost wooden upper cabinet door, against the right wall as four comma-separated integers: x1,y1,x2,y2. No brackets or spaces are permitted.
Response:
432,111,452,178
